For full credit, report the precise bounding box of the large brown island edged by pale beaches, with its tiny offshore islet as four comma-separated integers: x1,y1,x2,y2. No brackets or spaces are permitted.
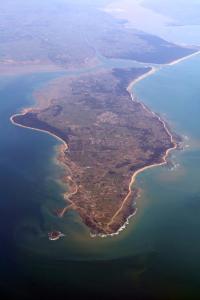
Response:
11,67,177,239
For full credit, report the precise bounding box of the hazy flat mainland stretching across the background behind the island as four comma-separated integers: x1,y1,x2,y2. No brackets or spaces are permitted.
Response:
0,0,195,74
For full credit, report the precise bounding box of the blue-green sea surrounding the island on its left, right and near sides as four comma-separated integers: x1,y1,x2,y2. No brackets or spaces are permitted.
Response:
0,56,200,300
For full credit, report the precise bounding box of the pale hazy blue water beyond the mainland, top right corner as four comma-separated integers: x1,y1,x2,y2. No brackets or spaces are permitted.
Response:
104,0,200,45
